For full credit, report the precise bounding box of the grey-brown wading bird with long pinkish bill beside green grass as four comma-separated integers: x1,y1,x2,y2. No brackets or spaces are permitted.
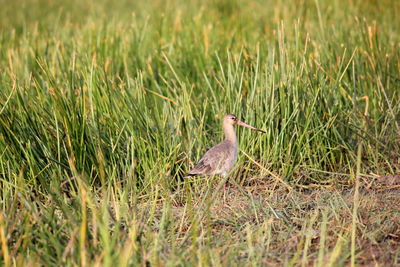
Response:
187,114,265,177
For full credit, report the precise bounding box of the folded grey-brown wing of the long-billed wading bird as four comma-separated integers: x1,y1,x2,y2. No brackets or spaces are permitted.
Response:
188,142,231,176
